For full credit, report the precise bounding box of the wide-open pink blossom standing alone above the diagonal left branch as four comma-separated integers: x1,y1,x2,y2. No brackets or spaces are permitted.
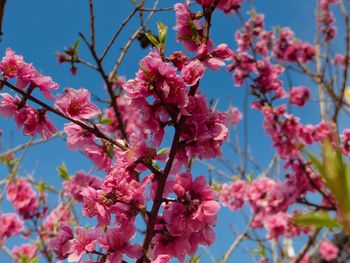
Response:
56,88,100,120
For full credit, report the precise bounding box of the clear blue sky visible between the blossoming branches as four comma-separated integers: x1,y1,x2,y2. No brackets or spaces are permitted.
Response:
0,0,339,262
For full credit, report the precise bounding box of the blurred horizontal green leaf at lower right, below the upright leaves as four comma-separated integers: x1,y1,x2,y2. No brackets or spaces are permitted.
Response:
293,211,341,229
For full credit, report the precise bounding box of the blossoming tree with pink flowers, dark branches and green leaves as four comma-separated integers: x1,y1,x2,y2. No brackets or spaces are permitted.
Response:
0,0,350,263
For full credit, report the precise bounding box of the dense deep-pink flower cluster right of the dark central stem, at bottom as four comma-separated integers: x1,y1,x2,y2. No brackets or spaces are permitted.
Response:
152,172,220,261
